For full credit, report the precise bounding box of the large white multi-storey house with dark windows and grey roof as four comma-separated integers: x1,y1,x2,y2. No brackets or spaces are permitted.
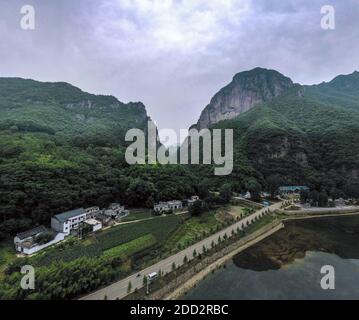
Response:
51,208,89,234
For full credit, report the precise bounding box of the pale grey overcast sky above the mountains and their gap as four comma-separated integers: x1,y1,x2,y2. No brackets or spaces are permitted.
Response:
0,0,359,144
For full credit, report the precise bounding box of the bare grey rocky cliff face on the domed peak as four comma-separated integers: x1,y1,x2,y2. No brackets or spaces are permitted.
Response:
197,68,294,129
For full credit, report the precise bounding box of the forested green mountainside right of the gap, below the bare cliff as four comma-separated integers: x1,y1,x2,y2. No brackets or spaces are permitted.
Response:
208,70,359,197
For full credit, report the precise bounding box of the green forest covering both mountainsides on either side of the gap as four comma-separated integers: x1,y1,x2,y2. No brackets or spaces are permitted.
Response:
0,73,359,239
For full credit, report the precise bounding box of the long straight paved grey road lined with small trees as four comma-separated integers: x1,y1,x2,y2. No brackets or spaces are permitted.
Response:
80,202,282,300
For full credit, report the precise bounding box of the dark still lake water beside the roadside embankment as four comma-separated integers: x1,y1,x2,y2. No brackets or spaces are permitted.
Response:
183,217,359,300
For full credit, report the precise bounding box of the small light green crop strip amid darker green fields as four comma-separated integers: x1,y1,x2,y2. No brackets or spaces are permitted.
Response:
103,234,157,258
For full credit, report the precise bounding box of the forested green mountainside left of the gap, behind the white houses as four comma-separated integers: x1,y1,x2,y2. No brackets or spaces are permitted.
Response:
0,78,200,238
